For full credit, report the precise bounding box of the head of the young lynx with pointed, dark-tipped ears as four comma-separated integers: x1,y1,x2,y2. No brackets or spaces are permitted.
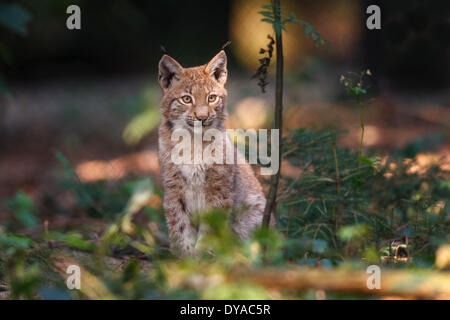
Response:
158,51,227,129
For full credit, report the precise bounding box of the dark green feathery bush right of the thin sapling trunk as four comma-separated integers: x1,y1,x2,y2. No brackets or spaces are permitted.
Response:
279,129,450,261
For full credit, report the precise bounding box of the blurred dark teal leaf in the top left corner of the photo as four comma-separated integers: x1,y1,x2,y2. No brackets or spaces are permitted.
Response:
0,3,31,36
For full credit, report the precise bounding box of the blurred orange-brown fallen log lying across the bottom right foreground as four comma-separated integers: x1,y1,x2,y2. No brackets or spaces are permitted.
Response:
228,268,450,299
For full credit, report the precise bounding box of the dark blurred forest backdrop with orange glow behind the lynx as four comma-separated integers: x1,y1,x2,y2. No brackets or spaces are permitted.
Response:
0,0,450,224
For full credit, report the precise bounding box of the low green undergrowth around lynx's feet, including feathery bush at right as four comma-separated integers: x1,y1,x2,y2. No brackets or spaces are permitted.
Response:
0,134,450,299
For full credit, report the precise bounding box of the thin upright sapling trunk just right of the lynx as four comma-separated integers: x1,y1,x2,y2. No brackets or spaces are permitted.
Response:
263,0,283,228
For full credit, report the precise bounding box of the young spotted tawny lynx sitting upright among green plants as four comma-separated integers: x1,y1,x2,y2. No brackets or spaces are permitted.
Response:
158,51,266,256
